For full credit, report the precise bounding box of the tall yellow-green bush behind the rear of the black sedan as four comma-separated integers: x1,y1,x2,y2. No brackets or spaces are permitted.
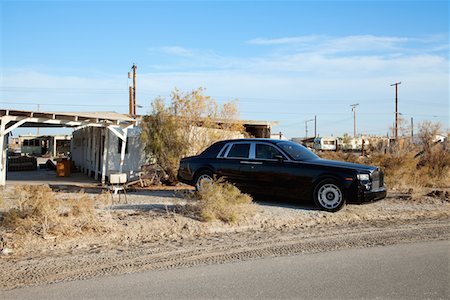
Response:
141,88,243,183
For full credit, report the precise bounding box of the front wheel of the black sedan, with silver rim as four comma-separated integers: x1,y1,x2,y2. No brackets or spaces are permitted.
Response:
313,178,345,212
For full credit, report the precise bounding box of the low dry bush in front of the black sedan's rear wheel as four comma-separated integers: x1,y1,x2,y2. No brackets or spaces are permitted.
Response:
185,179,254,223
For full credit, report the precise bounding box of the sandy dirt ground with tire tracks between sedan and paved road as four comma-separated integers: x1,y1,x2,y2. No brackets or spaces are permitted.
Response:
0,187,450,290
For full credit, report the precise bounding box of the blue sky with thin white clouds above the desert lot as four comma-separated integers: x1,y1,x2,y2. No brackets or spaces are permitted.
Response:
0,1,449,137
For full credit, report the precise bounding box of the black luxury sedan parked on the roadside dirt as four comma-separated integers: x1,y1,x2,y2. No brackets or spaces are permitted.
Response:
178,139,386,211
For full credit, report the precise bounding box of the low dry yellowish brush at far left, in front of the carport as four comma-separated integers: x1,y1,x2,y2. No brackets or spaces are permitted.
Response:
1,185,110,237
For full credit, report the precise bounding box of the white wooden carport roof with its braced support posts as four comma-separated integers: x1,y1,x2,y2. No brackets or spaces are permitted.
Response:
0,109,136,186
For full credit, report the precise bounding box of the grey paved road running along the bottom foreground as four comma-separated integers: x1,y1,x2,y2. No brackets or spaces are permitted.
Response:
0,241,450,299
